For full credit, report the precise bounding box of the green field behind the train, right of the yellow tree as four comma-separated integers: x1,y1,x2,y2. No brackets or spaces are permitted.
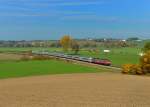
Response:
79,48,141,67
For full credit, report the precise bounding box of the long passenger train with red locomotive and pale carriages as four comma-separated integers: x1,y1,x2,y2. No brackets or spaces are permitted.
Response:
32,51,112,66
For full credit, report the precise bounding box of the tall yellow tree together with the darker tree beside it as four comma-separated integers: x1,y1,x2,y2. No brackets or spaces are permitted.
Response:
60,35,80,54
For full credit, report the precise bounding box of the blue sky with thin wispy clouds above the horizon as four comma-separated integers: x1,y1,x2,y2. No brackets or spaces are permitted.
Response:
0,0,150,40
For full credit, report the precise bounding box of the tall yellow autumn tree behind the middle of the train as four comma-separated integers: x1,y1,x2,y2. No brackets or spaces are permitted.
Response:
60,35,72,51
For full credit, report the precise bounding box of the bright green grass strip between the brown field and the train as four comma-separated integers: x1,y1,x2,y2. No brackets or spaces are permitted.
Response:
0,60,106,79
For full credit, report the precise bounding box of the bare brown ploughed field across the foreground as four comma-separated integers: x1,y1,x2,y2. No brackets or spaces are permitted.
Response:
0,73,150,107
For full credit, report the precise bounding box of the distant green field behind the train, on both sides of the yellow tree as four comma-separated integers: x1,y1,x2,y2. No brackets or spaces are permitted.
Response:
0,47,141,67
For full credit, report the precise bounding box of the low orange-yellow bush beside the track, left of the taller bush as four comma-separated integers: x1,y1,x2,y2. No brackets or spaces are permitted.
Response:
122,64,144,75
